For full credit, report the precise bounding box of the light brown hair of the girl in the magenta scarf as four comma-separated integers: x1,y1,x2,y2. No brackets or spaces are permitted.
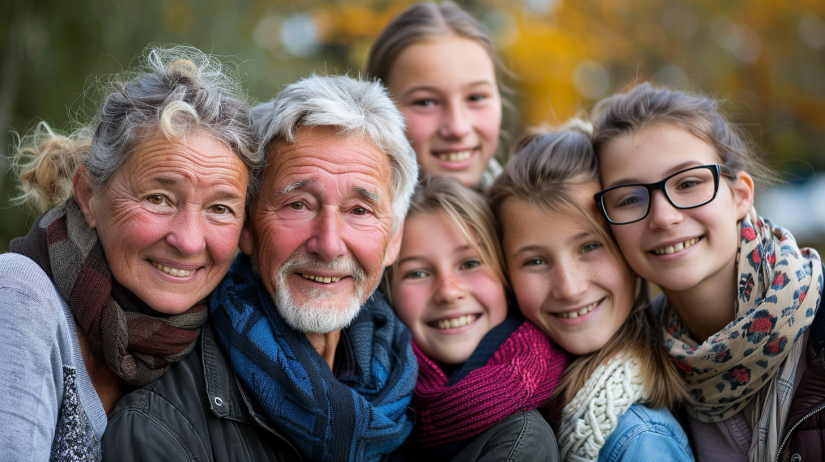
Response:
383,176,509,303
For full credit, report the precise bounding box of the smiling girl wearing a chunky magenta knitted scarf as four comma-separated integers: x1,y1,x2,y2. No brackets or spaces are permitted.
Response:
385,177,566,461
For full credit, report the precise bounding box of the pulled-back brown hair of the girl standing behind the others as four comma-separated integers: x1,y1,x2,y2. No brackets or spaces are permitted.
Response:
367,1,507,92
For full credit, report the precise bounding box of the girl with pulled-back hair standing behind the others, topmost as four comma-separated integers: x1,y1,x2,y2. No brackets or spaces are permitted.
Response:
367,2,501,188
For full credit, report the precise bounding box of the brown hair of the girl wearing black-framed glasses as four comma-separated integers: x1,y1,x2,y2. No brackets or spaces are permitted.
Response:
592,82,777,185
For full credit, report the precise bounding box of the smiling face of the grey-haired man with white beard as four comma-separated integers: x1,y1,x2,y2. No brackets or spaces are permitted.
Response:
241,127,395,333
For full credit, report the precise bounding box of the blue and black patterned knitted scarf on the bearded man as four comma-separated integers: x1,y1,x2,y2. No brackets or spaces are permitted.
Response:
209,255,418,461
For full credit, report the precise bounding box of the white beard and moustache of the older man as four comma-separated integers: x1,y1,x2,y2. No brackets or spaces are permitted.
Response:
273,251,375,334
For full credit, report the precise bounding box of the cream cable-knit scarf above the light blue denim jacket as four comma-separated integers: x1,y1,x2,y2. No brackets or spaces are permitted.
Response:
558,355,644,460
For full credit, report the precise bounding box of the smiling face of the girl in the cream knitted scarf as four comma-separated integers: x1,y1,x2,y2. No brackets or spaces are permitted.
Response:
501,181,634,355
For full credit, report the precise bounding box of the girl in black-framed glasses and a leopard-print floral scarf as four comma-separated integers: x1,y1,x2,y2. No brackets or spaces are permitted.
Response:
594,84,825,462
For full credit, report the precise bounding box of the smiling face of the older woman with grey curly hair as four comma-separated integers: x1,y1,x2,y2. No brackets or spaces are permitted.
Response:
75,133,249,314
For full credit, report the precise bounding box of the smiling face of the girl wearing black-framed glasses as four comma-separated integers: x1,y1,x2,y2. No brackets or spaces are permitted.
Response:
599,124,753,297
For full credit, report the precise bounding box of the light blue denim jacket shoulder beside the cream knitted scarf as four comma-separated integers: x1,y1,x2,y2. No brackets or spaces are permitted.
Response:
599,403,694,461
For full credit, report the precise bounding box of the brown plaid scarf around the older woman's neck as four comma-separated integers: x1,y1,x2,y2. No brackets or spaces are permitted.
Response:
9,199,209,386
